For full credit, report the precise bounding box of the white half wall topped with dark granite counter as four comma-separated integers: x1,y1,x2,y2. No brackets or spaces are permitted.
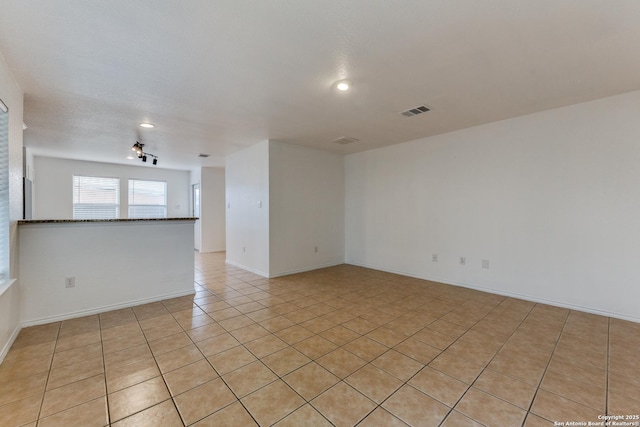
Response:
18,218,195,326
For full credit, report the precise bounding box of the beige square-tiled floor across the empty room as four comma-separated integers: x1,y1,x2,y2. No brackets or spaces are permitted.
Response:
0,253,640,427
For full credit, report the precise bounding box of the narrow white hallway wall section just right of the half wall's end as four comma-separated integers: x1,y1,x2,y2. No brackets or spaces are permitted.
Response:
200,167,226,253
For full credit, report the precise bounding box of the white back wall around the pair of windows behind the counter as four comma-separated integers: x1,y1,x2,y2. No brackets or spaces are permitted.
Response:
33,156,190,219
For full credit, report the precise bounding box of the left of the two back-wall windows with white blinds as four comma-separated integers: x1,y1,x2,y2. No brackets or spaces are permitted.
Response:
73,175,120,219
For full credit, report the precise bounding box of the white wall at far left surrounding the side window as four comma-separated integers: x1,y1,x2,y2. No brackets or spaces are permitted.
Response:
0,54,23,362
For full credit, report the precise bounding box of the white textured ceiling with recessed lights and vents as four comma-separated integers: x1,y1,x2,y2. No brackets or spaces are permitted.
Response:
0,0,640,169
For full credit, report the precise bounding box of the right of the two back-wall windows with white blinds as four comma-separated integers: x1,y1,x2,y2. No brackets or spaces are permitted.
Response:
129,179,167,218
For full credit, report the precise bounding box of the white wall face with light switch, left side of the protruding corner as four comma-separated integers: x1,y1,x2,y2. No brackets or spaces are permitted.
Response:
225,141,269,277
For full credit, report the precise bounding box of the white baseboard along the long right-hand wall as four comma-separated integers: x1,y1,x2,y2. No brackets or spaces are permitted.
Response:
346,261,640,323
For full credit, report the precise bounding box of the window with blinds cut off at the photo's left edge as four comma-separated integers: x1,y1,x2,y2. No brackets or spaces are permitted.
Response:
0,100,9,285
